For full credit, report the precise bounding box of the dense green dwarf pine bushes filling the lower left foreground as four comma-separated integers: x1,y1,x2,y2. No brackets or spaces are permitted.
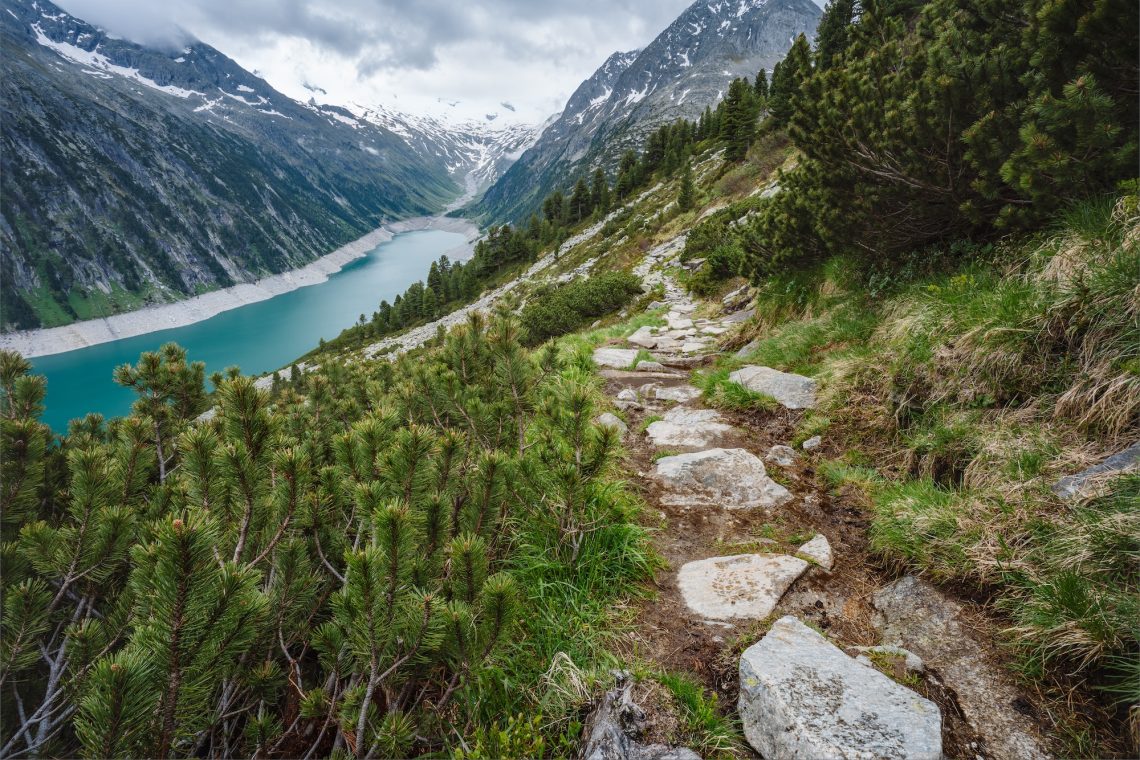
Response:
0,307,649,758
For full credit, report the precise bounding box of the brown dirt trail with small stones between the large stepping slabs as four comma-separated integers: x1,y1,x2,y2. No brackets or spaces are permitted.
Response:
595,243,1043,759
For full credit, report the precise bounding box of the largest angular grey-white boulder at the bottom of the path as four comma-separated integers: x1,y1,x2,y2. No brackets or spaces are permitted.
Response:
739,616,942,760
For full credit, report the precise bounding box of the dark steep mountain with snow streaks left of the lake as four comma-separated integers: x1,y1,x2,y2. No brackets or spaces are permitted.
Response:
0,0,458,329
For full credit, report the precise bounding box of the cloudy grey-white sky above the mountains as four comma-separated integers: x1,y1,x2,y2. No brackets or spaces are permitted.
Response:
56,0,692,122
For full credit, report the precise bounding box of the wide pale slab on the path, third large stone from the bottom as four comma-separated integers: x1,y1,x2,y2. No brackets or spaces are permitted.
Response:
650,449,792,509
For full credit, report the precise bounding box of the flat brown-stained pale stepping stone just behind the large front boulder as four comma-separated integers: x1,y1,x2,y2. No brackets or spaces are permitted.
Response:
677,554,807,620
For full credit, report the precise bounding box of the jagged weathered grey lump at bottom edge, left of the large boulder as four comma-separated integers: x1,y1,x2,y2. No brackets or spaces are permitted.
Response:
581,675,701,760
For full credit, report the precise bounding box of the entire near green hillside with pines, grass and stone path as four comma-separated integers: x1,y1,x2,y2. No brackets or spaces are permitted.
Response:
0,0,1140,759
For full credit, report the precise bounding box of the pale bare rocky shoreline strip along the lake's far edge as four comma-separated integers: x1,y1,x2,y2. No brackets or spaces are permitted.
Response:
0,216,480,359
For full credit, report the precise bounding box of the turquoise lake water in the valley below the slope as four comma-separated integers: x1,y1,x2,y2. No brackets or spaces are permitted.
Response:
31,230,465,433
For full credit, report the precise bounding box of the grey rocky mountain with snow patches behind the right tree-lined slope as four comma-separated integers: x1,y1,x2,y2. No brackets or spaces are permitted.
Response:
472,0,821,221
